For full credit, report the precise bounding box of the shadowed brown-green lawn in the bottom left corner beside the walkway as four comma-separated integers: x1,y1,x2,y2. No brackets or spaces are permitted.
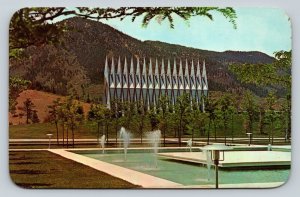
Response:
9,151,139,188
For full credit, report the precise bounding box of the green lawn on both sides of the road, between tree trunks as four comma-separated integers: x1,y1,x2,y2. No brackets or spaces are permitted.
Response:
9,112,290,148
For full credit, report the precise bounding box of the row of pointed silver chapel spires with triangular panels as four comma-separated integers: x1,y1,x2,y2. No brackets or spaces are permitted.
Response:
104,57,208,110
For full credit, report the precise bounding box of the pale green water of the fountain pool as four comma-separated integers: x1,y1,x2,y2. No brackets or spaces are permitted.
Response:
80,150,290,185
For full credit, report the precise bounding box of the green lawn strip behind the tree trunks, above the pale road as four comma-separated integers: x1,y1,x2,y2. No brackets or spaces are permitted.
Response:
9,117,285,140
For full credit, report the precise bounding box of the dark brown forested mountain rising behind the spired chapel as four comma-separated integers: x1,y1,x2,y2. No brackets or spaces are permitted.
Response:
10,17,274,100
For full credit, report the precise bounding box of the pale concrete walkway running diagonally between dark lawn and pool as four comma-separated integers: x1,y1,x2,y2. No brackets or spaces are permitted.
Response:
49,149,183,188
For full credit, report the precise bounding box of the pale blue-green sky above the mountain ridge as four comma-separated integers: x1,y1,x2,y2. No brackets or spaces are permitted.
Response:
101,8,292,56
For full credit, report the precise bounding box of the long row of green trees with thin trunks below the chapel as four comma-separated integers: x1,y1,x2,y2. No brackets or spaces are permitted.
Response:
44,91,288,146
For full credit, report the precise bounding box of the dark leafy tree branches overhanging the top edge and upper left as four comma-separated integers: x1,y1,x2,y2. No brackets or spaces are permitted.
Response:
9,7,237,57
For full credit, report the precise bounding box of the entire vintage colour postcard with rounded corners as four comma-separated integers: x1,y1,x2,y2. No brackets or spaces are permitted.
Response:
9,7,292,189
